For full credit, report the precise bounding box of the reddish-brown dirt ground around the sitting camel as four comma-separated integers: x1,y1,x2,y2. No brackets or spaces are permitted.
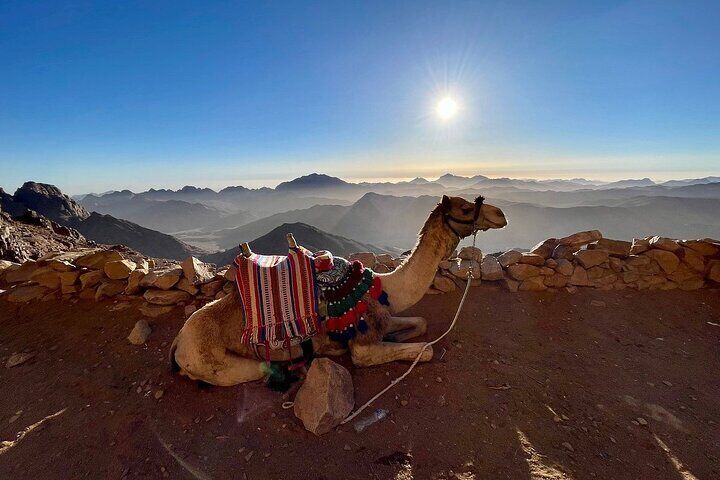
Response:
0,285,720,479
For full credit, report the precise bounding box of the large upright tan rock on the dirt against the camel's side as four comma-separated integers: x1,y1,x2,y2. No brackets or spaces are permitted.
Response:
293,358,355,435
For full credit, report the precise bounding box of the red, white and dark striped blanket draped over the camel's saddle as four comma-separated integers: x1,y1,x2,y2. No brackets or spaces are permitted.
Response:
235,247,320,349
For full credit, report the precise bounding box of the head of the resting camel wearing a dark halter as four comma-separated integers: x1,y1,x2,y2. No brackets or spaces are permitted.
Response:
440,195,507,238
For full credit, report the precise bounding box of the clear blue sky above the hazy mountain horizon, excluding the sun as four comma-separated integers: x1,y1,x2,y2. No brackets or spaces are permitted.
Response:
0,0,720,193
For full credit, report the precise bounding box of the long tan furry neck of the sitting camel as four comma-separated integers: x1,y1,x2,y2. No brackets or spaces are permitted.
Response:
381,210,459,313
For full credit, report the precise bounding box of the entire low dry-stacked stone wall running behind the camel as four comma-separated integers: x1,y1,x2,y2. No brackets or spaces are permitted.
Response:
0,230,720,317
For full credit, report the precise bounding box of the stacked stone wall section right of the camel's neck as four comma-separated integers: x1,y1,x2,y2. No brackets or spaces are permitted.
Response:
428,230,720,294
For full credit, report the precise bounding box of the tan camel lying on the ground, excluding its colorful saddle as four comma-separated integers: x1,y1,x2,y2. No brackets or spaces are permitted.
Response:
170,195,507,386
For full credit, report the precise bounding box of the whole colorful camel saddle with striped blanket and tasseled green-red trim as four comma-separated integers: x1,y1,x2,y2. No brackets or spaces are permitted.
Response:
235,247,388,352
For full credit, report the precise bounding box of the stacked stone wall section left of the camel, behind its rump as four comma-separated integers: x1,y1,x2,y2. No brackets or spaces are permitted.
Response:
0,248,235,317
